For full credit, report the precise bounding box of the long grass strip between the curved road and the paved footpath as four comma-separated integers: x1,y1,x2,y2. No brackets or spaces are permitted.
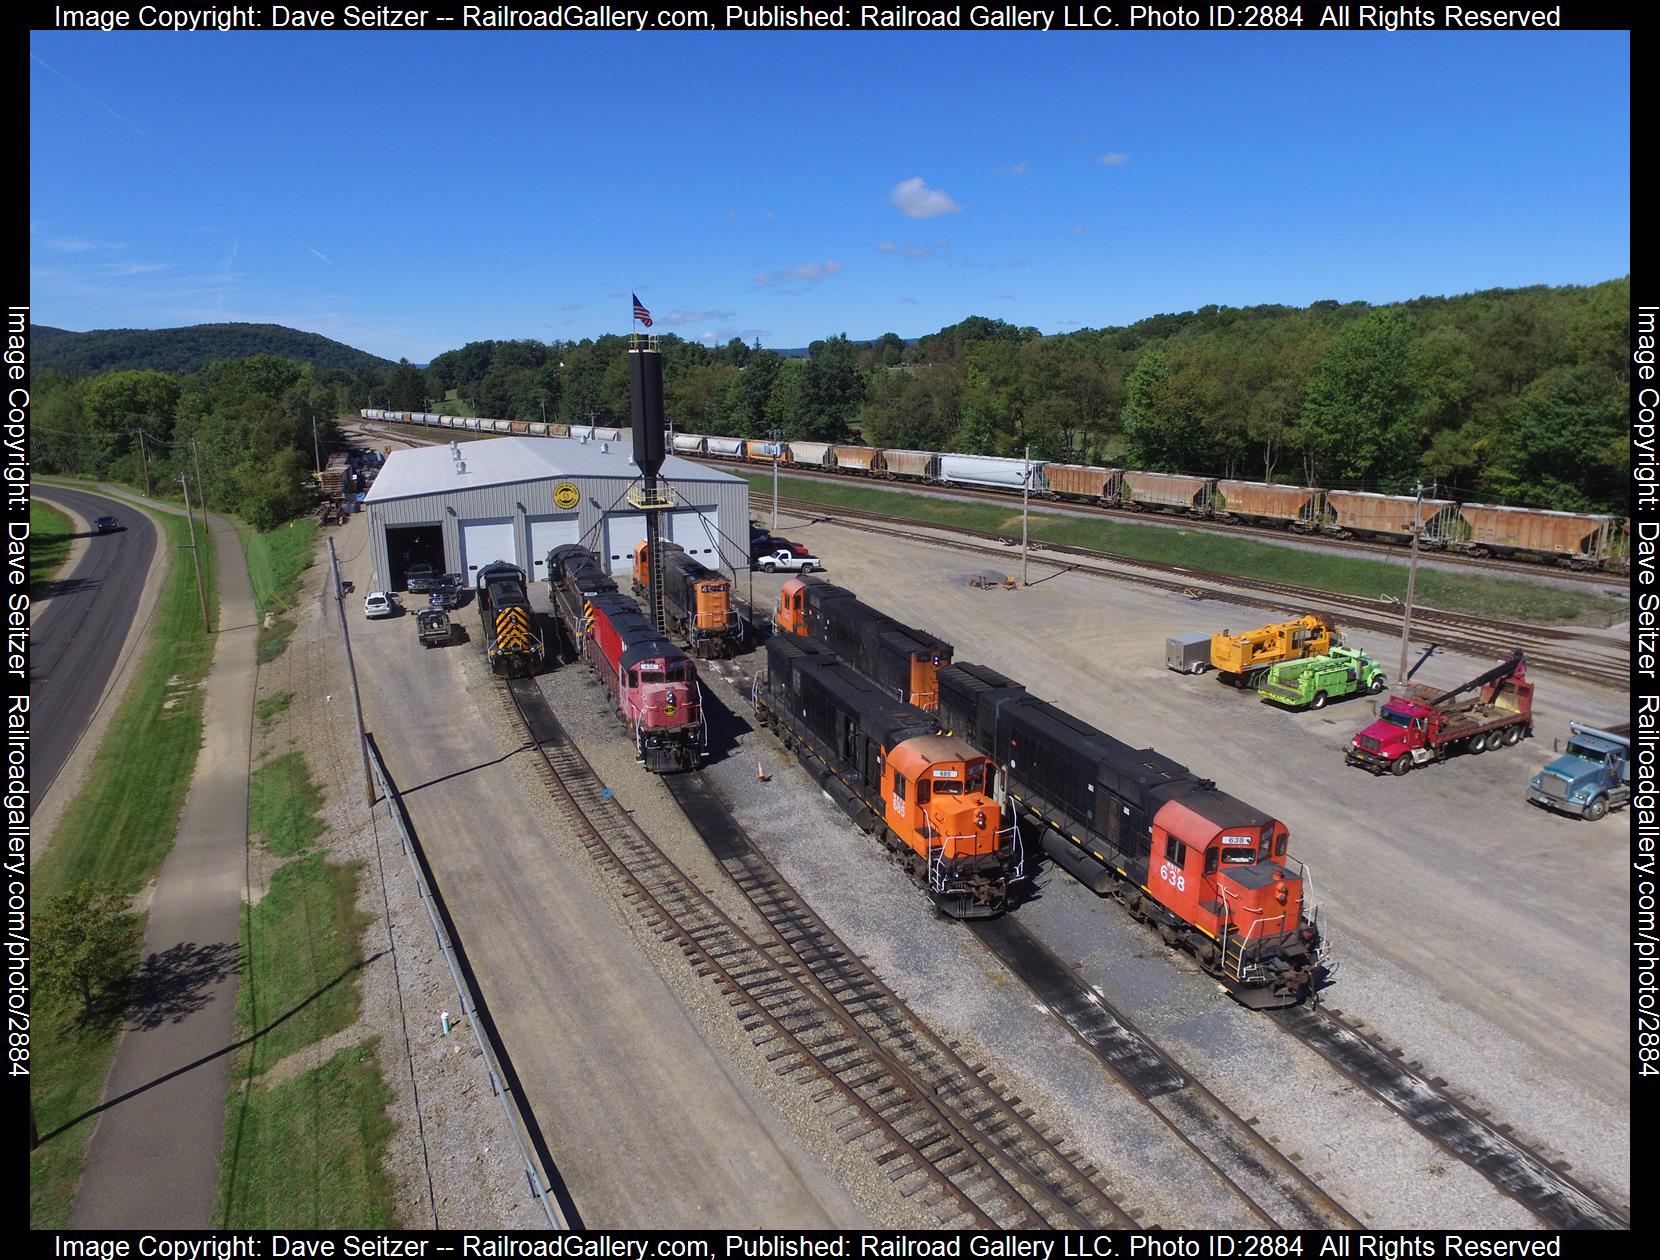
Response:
30,513,219,1228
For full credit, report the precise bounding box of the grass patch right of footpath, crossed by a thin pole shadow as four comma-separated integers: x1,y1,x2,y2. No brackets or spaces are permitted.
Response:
236,853,369,1077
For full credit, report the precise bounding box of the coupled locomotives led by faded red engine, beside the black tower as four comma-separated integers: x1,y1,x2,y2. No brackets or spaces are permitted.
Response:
548,543,709,774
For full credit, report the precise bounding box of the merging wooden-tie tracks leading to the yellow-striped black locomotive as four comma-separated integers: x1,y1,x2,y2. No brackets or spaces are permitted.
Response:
505,679,1140,1228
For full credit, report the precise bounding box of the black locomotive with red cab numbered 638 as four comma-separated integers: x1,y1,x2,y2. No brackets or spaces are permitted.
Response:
940,664,1325,1009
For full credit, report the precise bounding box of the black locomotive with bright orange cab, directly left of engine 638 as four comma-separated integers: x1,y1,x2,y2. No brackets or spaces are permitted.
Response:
754,634,1024,918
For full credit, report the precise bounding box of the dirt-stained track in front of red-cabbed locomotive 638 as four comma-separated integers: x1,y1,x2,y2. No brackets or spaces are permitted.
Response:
1268,1006,1632,1230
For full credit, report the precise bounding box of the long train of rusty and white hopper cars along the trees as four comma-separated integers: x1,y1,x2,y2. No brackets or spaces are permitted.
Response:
362,408,1628,569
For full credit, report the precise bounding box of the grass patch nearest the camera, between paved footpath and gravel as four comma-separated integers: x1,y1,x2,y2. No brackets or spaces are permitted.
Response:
214,1038,398,1230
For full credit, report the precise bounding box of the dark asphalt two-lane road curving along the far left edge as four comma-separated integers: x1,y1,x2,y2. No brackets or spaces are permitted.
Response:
28,486,156,813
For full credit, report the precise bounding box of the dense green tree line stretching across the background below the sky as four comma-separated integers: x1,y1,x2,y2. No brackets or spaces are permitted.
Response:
33,279,1630,525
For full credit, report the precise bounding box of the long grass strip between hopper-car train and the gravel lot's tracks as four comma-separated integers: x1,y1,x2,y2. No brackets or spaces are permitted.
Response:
742,470,1627,626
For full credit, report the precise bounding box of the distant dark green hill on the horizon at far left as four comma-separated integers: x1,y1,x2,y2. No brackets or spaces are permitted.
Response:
28,324,397,377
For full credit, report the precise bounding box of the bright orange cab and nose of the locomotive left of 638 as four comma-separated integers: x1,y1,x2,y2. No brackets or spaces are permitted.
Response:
881,735,1019,918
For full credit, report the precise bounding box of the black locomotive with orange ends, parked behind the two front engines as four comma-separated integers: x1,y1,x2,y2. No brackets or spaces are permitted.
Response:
775,578,953,711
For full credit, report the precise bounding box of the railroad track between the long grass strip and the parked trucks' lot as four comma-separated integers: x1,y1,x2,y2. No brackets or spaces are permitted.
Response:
779,500,1630,689
